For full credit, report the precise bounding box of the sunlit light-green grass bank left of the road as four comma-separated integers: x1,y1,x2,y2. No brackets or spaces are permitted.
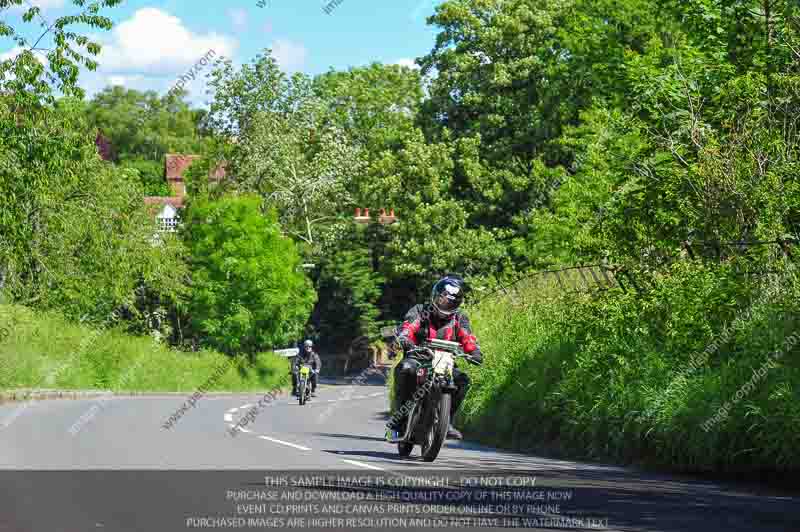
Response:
0,305,289,391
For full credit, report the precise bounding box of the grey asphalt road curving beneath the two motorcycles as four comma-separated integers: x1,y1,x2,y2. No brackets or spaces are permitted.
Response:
0,376,800,532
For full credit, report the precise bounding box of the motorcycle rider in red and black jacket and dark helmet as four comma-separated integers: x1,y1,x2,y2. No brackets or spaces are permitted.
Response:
388,275,483,440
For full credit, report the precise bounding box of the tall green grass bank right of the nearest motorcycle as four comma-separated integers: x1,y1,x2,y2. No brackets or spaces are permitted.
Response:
461,263,800,472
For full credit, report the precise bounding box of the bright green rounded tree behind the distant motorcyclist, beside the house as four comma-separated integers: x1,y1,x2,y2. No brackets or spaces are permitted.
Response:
184,195,315,355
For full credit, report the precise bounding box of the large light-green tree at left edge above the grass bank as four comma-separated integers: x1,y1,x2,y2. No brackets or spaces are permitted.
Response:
0,1,185,321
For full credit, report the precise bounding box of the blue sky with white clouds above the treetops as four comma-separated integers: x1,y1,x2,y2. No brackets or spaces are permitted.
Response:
0,0,440,105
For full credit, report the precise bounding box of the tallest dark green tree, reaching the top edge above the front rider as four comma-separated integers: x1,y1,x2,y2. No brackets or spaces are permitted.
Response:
420,0,663,235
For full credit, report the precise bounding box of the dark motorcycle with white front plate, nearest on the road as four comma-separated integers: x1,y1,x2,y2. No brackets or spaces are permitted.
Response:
386,339,482,462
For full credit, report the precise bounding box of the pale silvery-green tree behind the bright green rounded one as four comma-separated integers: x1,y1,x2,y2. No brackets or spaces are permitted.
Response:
209,50,362,253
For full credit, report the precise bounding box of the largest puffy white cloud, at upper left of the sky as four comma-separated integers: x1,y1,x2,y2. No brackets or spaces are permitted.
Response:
97,7,238,76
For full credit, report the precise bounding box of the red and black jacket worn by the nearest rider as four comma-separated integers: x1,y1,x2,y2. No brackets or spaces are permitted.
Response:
397,305,481,358
